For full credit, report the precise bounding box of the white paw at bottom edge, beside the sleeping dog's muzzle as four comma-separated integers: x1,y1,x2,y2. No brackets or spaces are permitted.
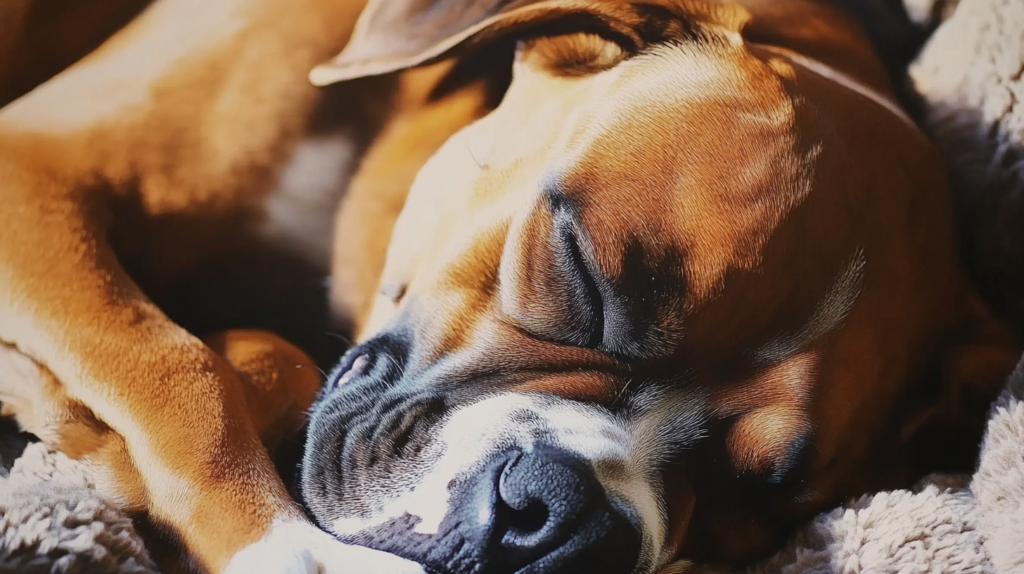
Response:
224,521,424,574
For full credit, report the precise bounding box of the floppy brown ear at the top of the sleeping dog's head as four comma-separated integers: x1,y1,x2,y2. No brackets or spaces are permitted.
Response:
309,0,752,86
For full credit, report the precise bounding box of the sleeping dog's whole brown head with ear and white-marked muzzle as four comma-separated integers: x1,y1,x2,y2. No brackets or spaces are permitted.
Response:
302,0,1013,574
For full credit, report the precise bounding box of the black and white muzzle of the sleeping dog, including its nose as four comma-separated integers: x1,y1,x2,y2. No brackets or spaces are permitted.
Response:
302,339,642,574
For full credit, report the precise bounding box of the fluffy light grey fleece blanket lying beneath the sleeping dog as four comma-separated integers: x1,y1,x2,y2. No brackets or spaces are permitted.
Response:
0,0,1024,574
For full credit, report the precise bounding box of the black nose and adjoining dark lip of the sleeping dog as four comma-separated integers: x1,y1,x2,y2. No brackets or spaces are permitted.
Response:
345,447,640,574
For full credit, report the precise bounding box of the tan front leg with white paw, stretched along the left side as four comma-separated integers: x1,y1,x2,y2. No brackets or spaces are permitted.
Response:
0,164,418,572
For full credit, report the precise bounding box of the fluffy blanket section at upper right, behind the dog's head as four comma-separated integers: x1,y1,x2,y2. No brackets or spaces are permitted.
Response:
907,0,1024,324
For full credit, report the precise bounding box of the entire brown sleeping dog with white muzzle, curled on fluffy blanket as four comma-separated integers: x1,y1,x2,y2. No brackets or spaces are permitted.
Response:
0,0,1014,572
